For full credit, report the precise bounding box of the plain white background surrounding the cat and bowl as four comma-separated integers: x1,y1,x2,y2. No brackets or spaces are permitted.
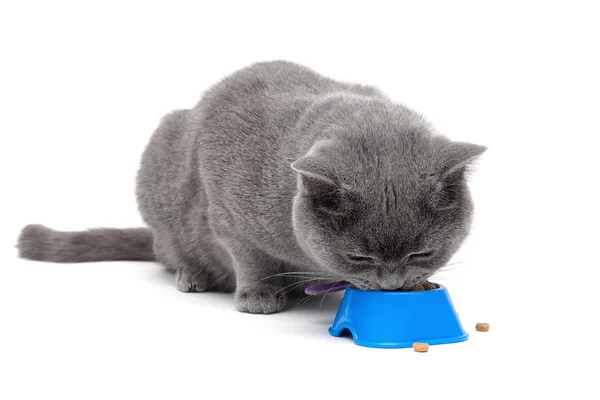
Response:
0,1,600,400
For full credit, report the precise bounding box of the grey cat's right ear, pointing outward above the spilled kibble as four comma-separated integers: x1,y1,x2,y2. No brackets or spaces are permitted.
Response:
436,142,487,179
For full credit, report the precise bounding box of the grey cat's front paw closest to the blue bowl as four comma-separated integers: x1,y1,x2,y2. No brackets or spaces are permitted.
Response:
235,284,286,314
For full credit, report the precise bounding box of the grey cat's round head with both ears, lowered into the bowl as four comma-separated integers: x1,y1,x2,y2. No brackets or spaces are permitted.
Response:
292,131,486,290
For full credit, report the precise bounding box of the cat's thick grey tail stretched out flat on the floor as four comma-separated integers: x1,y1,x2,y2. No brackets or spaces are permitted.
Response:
17,225,155,263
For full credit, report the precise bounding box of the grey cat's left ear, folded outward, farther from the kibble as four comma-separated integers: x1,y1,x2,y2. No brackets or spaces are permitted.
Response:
291,155,344,214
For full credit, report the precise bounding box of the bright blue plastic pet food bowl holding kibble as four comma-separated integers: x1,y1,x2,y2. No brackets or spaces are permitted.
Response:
329,284,469,348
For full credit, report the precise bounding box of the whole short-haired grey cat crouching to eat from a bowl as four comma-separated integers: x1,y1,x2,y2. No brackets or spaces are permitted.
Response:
18,61,485,313
